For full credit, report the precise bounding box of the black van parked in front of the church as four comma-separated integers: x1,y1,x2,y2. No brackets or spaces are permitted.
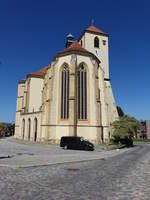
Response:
60,136,94,151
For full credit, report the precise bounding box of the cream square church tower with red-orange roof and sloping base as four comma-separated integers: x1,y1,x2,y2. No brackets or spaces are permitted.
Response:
78,25,118,130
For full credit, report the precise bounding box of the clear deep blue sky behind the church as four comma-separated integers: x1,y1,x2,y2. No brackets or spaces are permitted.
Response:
0,0,150,122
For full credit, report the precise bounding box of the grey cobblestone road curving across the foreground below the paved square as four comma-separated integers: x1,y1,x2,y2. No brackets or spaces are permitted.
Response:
0,138,150,200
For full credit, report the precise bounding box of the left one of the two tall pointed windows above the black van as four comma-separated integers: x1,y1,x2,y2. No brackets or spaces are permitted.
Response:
61,65,69,119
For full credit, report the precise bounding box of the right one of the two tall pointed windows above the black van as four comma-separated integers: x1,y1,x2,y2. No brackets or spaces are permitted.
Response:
77,64,87,120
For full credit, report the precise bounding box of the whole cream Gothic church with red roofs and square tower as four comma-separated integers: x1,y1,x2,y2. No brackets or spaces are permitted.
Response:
15,25,118,144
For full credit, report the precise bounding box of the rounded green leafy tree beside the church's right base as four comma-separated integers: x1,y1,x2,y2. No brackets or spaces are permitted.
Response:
112,115,142,144
